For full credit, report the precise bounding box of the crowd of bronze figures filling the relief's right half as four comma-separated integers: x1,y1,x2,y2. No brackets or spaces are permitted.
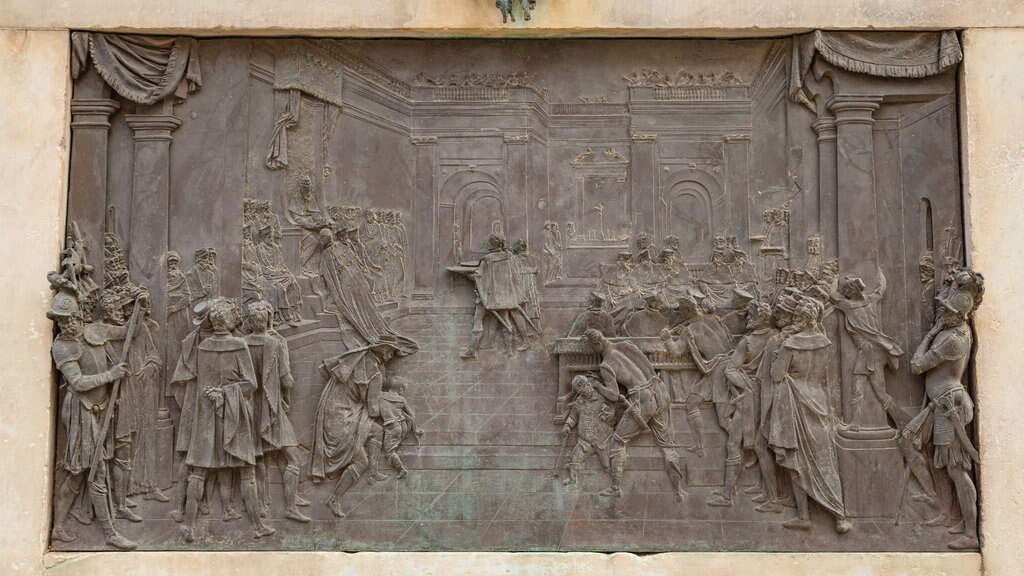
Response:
556,229,984,549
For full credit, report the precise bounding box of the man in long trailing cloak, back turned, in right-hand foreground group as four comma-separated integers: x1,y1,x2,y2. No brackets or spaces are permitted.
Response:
768,298,853,534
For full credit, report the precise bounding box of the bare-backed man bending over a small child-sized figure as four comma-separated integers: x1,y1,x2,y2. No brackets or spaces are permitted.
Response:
582,329,683,500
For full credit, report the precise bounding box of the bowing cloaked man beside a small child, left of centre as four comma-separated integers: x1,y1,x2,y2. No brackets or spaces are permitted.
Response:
309,338,402,518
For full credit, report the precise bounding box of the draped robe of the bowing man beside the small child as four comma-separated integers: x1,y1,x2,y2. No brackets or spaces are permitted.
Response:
309,351,384,481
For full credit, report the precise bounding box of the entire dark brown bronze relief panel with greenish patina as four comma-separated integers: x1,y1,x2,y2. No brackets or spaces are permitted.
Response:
49,32,984,552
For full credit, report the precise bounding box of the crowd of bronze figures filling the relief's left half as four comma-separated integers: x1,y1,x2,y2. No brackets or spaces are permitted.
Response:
48,183,417,549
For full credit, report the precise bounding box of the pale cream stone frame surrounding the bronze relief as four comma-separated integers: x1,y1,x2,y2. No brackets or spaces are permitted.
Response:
0,0,1024,575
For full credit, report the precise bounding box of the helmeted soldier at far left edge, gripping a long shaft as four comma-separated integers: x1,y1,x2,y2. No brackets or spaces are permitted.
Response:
46,290,136,550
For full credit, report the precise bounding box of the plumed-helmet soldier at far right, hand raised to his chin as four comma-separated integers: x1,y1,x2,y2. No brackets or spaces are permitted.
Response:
900,270,984,550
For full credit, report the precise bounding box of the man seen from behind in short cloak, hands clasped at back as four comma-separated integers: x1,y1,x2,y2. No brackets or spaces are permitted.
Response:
174,299,275,542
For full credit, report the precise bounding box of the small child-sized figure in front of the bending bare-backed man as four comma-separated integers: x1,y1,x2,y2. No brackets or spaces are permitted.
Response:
559,374,617,485
